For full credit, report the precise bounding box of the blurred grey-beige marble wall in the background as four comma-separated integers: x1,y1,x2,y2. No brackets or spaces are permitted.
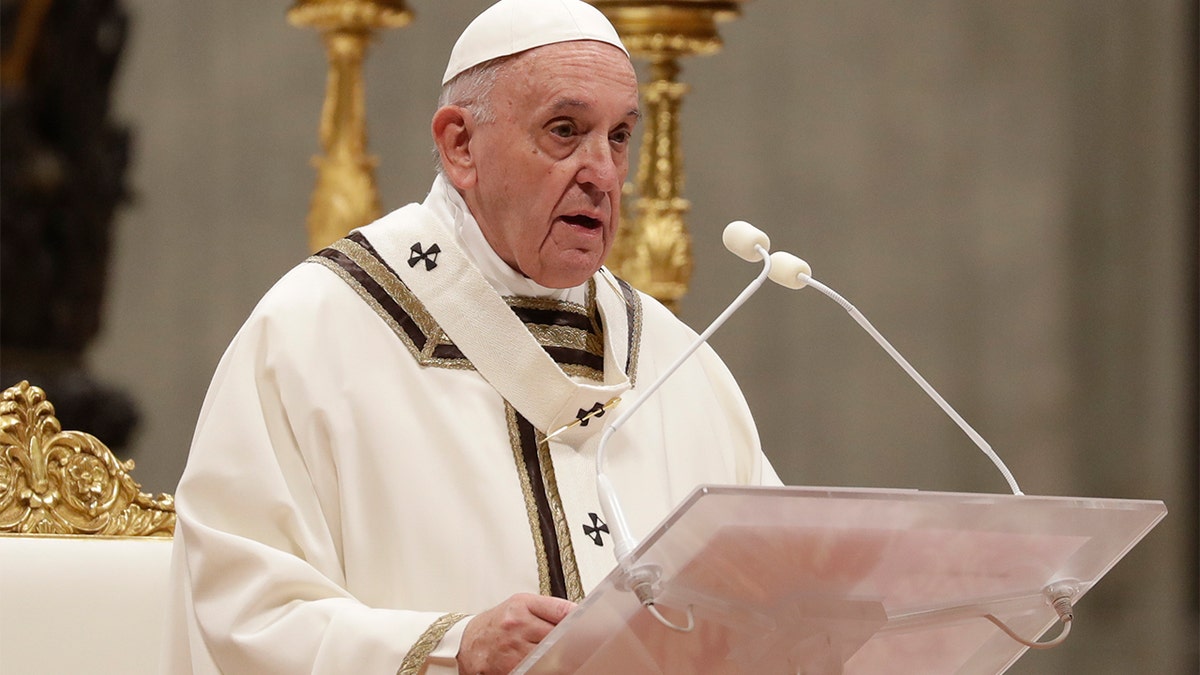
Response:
84,0,1198,673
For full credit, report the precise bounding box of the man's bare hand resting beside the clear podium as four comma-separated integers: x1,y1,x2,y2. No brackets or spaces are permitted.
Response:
457,593,575,675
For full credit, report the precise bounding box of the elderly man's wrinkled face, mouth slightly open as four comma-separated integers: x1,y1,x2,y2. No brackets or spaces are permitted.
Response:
453,41,638,288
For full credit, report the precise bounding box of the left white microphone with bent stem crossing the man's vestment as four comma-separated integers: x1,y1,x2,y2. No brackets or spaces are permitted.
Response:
596,220,777,562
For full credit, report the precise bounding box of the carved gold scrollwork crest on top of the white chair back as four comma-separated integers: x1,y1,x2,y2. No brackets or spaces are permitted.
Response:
0,382,175,537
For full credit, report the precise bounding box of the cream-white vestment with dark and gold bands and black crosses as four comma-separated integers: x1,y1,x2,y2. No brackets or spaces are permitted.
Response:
164,179,779,675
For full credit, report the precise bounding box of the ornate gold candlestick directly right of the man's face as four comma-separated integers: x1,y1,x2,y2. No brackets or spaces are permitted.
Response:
588,0,745,311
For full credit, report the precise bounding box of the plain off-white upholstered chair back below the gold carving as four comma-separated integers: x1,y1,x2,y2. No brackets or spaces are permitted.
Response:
0,534,172,675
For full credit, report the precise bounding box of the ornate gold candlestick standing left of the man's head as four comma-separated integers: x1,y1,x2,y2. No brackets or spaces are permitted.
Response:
288,0,413,251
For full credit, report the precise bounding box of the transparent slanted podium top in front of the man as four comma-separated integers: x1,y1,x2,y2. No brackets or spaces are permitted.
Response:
515,486,1166,675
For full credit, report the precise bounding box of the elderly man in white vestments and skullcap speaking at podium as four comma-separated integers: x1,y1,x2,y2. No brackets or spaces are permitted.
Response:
167,0,778,674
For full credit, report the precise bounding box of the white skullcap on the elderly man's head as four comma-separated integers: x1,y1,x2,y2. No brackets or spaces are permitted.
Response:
442,0,629,84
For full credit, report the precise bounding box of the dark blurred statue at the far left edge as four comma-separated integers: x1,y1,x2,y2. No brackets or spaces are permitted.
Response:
0,0,137,448
